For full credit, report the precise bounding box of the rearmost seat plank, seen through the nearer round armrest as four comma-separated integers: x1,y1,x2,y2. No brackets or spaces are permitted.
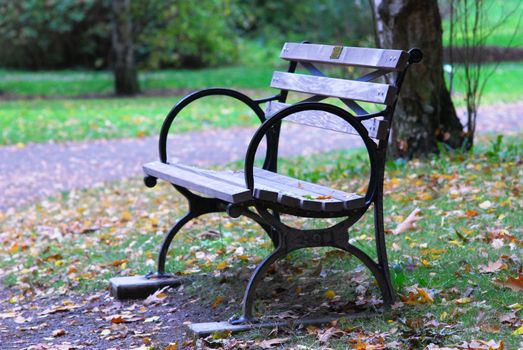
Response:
254,168,365,209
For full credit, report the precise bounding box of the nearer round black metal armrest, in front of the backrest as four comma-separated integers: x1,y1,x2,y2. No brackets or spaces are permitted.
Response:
244,102,380,204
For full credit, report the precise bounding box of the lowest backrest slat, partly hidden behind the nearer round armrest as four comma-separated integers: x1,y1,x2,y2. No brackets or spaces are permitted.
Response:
265,101,388,140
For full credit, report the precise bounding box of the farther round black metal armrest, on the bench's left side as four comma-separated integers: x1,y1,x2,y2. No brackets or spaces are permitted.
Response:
158,88,270,163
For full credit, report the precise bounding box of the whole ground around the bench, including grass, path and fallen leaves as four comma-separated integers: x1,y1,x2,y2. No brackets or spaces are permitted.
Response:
0,63,523,350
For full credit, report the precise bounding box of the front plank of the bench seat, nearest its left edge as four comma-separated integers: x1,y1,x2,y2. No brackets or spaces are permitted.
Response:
143,161,252,203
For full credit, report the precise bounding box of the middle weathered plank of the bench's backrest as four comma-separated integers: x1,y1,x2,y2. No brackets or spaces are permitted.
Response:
271,72,397,104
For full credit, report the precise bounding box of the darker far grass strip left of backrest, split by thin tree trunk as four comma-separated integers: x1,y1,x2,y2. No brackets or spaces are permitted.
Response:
0,67,274,96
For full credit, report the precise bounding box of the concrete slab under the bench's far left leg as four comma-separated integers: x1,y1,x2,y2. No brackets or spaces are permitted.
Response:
109,276,187,300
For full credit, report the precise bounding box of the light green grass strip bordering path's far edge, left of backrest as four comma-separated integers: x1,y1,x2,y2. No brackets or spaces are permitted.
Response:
0,93,266,145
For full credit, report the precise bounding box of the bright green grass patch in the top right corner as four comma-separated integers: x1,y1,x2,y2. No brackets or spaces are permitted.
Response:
443,0,523,47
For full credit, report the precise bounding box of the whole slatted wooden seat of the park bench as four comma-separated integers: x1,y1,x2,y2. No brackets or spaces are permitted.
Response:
143,161,365,212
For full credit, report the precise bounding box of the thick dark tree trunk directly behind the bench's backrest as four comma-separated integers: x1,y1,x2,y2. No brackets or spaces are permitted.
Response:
374,0,464,158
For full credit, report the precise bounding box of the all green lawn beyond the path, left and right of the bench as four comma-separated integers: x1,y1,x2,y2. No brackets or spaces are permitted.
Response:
0,63,523,145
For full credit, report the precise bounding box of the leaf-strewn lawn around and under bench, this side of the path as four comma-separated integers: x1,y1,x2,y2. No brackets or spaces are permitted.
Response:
0,135,523,349
